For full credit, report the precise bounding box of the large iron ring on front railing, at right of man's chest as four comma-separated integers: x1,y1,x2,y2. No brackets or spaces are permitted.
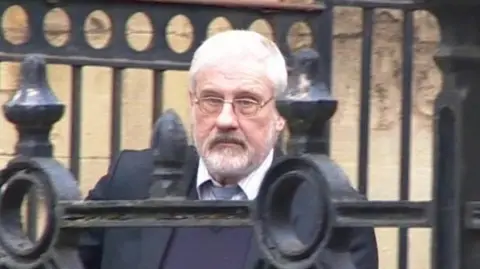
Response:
254,155,333,268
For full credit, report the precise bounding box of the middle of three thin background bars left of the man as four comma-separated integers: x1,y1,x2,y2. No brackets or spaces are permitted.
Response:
110,68,123,162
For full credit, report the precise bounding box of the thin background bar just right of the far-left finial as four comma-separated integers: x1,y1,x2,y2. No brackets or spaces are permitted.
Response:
70,65,82,180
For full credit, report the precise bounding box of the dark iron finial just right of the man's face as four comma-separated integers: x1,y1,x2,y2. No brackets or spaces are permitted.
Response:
277,49,337,154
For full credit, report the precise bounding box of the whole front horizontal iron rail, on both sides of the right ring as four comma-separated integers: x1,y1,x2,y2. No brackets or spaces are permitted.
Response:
59,199,436,228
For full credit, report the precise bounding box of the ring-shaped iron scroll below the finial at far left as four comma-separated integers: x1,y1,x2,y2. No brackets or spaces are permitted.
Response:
0,157,81,268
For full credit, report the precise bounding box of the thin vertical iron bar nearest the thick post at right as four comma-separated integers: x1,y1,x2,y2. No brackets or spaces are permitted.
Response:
398,10,414,269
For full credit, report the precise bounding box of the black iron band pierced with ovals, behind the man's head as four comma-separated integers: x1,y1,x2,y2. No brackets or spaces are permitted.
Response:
0,0,324,70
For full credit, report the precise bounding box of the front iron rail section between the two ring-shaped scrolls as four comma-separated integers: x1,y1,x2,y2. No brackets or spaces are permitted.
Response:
60,199,252,228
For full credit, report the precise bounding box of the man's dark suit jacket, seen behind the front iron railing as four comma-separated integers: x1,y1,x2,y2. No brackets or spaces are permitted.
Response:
80,148,378,269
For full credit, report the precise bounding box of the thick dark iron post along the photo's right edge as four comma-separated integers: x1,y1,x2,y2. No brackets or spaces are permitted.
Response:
429,6,480,269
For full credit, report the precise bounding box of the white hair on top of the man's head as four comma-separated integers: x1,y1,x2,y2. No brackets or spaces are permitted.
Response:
189,30,287,95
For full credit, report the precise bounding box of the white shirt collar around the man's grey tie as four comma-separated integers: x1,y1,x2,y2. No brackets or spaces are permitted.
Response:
196,149,273,200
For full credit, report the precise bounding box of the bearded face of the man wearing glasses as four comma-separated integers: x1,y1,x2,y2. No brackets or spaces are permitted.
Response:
190,62,284,178
